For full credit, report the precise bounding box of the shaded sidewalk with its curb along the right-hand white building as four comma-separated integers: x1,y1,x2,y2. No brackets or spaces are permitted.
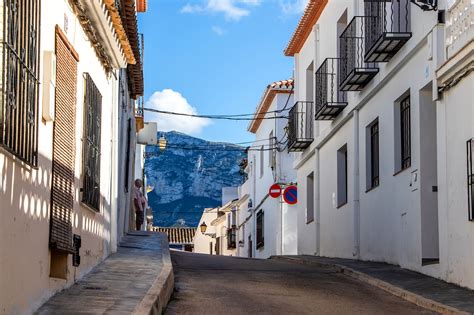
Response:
272,255,474,314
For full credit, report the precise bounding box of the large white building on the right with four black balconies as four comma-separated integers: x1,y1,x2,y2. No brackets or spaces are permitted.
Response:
285,0,474,288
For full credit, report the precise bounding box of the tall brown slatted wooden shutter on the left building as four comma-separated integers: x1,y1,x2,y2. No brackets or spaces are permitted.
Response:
49,28,77,253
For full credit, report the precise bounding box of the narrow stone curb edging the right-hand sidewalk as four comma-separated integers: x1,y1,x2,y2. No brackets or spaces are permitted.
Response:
270,256,471,315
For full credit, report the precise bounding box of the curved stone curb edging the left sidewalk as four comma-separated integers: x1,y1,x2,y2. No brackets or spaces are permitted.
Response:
132,233,174,315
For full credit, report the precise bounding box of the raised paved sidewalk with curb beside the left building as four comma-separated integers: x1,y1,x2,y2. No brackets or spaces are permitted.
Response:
37,232,174,314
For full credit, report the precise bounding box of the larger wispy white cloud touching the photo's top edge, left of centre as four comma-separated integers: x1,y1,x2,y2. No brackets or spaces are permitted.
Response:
180,0,262,21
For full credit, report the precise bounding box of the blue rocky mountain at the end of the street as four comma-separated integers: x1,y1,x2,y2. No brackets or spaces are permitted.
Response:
145,131,245,226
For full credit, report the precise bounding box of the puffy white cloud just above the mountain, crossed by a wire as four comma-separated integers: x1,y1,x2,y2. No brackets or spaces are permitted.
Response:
146,89,211,135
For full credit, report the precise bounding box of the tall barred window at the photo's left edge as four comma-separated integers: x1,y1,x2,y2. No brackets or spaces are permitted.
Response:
0,0,39,166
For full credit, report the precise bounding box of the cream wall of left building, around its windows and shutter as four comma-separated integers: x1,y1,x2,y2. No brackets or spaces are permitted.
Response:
0,0,122,314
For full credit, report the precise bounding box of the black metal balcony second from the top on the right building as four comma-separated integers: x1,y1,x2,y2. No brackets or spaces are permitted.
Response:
338,16,379,91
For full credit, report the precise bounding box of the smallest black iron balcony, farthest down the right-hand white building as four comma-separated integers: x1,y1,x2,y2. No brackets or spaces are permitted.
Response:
288,102,314,152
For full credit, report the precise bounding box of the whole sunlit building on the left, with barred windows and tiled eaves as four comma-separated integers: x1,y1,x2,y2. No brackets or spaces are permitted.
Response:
0,0,146,314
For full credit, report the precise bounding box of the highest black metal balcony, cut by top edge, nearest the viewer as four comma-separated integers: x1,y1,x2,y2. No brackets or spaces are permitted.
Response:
364,0,411,62
